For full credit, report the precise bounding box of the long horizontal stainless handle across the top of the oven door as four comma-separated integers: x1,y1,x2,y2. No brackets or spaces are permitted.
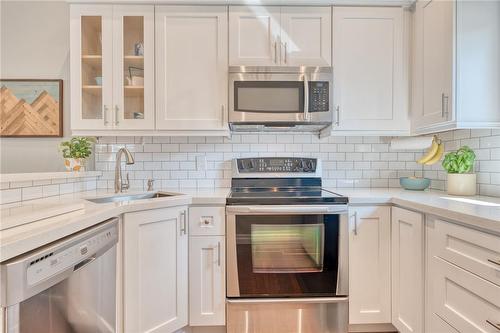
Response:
226,205,347,214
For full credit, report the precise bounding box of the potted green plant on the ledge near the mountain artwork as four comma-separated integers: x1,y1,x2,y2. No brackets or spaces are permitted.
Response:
59,136,94,171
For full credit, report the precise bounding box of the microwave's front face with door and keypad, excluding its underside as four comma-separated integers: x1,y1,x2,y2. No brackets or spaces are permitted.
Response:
229,73,332,124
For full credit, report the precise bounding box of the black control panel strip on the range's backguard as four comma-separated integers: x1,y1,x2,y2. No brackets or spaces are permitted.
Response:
237,157,318,173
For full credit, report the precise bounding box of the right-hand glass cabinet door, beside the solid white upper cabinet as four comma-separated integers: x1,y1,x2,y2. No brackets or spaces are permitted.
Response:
113,6,154,129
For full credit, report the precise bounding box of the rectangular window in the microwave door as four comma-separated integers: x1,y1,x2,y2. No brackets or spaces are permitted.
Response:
234,81,304,113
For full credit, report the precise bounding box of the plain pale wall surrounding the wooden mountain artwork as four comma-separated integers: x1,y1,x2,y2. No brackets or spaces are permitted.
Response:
0,0,70,173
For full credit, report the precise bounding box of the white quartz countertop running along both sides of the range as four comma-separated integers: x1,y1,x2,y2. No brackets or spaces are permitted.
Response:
0,188,500,262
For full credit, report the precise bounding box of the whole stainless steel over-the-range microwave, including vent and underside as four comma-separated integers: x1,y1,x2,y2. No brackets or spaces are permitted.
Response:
229,67,333,131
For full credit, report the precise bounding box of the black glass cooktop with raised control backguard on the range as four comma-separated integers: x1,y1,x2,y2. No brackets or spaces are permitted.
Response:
226,157,348,205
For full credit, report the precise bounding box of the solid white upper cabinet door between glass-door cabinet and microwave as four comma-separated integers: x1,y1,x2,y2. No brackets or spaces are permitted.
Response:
156,6,228,131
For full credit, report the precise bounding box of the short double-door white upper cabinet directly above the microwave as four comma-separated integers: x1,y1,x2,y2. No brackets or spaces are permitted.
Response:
229,6,331,66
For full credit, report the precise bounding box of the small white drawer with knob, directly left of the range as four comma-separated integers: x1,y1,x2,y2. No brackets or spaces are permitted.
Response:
189,206,226,236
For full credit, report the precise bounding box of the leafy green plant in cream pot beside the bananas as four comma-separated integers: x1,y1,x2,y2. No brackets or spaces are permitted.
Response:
442,146,476,195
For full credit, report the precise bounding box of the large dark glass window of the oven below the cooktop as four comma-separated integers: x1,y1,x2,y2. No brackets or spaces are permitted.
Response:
236,215,339,297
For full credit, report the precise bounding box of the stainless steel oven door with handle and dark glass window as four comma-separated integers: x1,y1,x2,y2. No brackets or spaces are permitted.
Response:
226,205,348,298
